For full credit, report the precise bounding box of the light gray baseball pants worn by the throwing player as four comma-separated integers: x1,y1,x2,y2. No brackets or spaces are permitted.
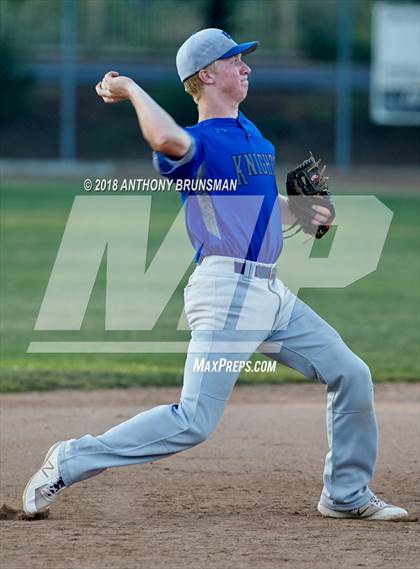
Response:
59,256,377,510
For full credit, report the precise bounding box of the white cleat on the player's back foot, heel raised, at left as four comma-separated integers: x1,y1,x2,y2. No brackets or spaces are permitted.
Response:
22,441,66,514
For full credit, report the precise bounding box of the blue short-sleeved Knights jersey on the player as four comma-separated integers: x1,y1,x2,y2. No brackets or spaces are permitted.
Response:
153,112,282,263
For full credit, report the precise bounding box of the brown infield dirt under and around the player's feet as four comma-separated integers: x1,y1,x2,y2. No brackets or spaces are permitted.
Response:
0,384,420,569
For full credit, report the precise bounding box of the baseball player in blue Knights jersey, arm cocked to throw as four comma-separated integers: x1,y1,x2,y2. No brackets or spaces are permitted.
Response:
23,28,408,520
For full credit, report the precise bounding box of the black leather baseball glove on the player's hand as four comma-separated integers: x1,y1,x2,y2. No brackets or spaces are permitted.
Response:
285,152,335,239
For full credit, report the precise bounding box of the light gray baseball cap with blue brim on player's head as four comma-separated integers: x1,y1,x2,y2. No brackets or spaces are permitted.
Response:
176,28,258,81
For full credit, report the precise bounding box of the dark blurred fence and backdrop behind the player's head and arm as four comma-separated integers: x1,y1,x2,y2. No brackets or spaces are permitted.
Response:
0,0,420,167
